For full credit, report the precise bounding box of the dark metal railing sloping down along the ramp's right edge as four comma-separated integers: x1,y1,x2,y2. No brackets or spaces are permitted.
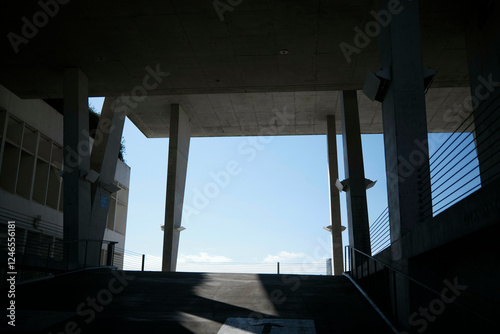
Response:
344,246,499,333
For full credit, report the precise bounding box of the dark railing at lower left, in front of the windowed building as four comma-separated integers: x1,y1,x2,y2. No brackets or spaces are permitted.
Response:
0,208,120,284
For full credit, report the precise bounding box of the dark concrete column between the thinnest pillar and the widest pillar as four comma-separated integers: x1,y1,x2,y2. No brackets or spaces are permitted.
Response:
340,90,371,254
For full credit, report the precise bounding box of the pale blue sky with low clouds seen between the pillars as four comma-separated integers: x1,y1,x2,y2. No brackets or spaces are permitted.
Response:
90,98,478,270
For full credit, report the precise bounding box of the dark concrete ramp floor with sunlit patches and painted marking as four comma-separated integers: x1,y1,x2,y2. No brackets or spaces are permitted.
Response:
0,270,391,334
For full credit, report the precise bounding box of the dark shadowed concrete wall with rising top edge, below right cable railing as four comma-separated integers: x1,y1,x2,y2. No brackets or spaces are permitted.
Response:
375,179,500,332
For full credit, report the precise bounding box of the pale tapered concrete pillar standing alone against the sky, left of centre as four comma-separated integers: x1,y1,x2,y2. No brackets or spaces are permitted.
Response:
162,104,191,271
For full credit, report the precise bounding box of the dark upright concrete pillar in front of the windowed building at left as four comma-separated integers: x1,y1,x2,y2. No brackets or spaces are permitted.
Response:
63,68,91,268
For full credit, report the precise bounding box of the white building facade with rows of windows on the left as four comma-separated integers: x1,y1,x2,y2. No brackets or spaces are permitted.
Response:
0,86,130,280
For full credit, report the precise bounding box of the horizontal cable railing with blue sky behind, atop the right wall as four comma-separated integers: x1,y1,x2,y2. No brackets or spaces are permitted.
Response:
420,90,500,220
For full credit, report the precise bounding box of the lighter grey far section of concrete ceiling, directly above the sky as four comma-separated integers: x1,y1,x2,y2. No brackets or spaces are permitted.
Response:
128,87,470,138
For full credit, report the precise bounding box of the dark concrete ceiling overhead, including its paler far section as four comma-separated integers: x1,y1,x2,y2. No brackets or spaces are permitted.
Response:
0,0,472,137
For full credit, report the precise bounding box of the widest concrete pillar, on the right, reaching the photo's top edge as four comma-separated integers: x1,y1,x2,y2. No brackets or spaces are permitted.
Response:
378,0,432,248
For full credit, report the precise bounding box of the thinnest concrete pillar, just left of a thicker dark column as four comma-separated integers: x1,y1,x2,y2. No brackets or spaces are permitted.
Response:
326,115,344,276
